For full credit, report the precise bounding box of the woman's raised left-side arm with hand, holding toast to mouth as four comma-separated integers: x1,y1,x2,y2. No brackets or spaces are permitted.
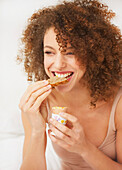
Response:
19,81,51,170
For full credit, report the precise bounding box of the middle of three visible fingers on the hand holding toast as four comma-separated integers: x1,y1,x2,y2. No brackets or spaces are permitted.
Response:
25,85,52,107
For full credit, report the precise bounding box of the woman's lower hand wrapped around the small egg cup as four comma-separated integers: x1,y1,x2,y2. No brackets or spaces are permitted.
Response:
49,113,86,154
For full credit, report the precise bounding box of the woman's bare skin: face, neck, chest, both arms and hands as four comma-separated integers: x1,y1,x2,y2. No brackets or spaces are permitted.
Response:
19,27,122,170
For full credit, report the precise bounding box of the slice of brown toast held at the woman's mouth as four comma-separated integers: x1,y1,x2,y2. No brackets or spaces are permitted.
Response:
48,76,68,87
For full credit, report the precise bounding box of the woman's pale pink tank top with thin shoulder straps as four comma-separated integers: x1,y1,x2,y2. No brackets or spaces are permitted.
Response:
48,88,122,170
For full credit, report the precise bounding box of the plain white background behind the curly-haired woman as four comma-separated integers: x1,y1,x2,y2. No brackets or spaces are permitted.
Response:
0,0,122,170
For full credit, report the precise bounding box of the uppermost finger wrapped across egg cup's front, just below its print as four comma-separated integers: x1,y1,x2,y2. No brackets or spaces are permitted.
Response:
49,118,73,136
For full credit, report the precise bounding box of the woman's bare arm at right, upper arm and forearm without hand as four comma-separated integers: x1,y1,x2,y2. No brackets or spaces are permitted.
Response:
81,98,122,170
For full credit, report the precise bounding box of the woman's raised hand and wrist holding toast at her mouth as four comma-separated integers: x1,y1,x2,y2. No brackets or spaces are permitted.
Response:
19,80,51,133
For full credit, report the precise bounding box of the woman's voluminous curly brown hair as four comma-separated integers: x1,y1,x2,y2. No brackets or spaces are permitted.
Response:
17,0,122,104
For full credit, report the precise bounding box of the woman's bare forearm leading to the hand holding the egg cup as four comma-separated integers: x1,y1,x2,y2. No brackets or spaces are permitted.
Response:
81,134,122,170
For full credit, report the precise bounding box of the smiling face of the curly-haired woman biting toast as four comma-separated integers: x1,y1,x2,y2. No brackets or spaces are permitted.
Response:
44,27,85,92
